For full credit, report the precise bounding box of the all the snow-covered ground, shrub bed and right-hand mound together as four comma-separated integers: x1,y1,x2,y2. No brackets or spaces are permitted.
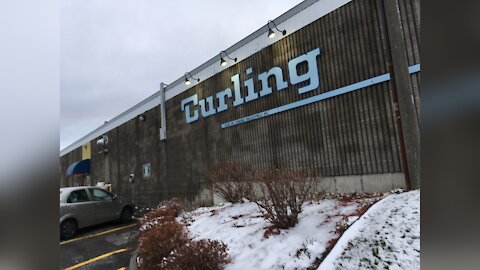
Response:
177,191,420,270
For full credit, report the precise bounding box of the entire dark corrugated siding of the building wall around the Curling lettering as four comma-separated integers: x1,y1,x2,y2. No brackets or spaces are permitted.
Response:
61,0,420,205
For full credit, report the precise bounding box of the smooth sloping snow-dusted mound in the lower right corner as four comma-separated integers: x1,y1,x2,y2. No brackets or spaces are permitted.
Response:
318,190,420,270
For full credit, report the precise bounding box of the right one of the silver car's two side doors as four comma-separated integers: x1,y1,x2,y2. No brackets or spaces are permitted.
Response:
89,188,120,223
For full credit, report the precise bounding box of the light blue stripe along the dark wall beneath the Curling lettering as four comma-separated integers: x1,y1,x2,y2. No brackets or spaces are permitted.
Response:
221,64,420,128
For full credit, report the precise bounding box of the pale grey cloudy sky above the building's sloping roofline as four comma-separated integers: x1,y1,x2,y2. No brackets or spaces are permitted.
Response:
60,0,301,149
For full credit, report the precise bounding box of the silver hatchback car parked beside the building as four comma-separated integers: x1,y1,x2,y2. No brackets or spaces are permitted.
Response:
60,186,134,239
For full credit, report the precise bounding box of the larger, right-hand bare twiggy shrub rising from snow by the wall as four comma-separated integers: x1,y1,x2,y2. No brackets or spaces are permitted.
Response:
252,169,316,229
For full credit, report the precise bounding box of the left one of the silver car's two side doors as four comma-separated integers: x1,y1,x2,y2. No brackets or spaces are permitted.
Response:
67,189,96,228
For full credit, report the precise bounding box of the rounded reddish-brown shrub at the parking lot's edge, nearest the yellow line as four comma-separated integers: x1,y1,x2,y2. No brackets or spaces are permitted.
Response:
138,222,189,270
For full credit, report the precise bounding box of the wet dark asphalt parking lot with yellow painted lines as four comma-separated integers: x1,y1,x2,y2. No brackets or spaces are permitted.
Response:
60,222,138,270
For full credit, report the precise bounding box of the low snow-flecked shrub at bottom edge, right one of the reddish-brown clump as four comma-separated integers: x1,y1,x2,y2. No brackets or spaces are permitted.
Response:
159,240,229,270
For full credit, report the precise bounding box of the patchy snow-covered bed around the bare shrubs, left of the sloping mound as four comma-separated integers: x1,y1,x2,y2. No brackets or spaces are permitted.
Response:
179,195,378,270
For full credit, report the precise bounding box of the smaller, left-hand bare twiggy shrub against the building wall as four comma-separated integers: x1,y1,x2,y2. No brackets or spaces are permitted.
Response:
207,161,253,203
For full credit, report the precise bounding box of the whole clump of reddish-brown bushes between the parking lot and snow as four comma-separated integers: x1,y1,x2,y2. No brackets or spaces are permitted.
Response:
138,199,228,270
